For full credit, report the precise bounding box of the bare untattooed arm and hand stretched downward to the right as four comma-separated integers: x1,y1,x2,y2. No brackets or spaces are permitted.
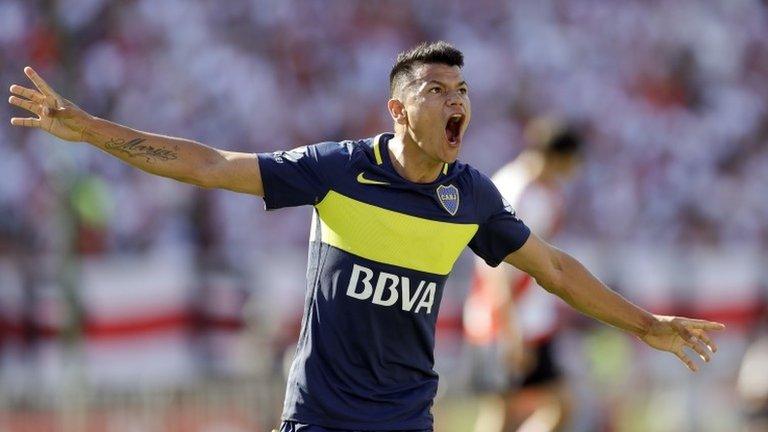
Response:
504,234,725,372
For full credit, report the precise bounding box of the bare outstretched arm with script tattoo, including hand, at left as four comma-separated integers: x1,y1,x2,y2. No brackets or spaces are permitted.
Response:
8,67,264,196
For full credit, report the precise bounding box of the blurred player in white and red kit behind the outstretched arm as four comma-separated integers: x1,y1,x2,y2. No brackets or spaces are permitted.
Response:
464,119,582,432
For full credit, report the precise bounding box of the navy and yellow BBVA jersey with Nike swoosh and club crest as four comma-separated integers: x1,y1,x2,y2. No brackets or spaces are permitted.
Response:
258,134,530,430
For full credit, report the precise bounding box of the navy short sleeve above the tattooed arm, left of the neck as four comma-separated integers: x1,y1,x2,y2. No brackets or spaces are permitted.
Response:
257,142,341,210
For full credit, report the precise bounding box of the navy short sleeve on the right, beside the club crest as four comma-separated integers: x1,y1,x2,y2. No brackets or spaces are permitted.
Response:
469,172,531,267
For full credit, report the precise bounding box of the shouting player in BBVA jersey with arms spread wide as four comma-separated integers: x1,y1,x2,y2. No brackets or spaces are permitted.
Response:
9,42,723,432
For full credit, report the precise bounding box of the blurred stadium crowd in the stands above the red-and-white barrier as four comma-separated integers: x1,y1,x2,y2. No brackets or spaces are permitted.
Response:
0,0,768,430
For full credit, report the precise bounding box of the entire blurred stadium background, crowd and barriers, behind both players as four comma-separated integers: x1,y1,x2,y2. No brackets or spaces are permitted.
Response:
0,0,768,431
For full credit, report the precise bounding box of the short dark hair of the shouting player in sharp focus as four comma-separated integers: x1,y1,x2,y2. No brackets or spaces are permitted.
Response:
389,41,464,96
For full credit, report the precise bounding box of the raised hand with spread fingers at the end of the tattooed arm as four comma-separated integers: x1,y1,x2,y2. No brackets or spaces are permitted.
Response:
8,66,91,141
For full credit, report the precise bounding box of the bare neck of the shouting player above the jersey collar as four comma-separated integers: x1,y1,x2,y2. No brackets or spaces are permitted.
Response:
387,134,444,183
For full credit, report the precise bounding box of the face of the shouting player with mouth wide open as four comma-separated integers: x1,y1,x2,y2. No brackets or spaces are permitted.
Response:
400,64,471,163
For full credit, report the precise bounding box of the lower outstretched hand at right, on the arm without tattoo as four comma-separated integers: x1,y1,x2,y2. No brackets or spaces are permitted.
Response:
640,315,725,372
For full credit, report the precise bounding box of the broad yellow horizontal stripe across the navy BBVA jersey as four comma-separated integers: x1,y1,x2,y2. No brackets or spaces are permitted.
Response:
316,191,478,275
